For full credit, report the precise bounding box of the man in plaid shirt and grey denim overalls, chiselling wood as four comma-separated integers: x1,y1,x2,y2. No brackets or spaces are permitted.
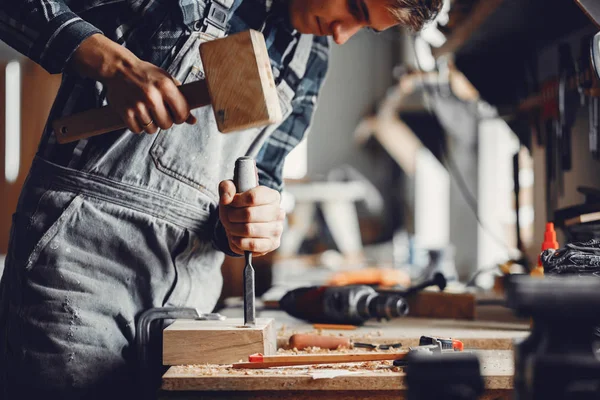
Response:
0,0,442,399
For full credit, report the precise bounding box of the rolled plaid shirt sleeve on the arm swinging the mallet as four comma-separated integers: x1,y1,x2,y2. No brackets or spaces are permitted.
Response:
0,0,102,74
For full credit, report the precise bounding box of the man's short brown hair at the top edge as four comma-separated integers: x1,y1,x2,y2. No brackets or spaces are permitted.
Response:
389,0,446,32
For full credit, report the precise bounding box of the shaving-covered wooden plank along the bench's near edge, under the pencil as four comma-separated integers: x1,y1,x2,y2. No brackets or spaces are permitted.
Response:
162,350,514,392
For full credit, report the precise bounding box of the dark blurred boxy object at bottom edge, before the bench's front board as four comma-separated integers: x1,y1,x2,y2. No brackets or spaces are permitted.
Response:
405,352,485,400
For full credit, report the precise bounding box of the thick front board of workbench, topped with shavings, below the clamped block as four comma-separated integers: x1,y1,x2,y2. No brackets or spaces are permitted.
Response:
162,350,513,400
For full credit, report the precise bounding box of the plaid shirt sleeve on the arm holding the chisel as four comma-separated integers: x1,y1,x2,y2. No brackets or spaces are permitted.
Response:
256,38,328,191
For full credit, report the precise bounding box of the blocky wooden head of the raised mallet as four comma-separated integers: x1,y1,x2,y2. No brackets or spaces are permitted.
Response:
200,30,282,133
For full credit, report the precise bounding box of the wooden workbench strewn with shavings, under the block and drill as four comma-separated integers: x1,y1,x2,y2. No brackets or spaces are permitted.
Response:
161,311,528,400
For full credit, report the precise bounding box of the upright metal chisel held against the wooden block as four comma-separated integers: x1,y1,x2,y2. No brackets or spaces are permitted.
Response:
233,157,258,326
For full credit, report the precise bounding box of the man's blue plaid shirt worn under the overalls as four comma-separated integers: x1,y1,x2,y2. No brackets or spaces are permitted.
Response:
0,0,328,190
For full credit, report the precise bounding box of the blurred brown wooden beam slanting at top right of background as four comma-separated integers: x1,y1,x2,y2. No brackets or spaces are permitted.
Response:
432,0,504,58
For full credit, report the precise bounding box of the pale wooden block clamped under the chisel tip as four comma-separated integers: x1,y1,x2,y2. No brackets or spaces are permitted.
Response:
163,318,277,365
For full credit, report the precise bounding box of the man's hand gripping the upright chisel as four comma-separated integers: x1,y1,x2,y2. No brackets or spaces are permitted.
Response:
219,181,285,256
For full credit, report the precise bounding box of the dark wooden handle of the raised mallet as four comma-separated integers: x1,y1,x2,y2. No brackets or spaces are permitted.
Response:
52,80,210,143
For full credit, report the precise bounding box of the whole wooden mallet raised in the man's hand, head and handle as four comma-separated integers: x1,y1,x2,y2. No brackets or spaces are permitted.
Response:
52,30,282,143
